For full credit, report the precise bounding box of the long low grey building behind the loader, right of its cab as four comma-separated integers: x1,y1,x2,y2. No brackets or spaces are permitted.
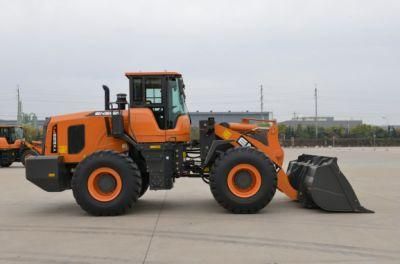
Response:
190,111,272,127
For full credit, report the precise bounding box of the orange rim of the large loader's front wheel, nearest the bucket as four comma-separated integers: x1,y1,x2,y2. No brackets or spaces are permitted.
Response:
227,164,261,198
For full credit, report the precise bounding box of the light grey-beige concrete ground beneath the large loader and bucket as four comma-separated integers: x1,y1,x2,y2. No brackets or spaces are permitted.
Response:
0,148,400,263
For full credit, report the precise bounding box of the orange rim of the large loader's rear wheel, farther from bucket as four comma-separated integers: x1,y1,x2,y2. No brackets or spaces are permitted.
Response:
88,168,122,202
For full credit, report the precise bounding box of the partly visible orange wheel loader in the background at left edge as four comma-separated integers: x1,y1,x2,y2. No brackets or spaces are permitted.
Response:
0,125,41,167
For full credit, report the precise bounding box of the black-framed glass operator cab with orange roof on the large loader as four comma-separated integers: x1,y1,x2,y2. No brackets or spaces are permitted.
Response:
125,72,188,129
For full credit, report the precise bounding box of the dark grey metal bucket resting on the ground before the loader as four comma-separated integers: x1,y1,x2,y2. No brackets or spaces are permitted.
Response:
287,154,373,213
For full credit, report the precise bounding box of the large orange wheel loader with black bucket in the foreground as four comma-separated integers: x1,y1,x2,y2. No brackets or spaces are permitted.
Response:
26,72,372,216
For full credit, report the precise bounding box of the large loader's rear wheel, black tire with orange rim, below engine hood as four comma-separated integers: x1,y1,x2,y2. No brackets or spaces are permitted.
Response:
71,151,142,216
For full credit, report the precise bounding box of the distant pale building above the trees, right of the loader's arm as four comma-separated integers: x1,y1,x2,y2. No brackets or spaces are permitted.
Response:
280,116,362,129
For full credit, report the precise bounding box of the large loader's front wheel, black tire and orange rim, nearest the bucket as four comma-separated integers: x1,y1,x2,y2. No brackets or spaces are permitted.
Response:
210,147,277,214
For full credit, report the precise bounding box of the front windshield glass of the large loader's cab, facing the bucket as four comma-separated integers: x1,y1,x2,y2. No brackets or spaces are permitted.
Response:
168,78,188,128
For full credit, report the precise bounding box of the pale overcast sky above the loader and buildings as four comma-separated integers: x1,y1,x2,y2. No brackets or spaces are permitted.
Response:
0,0,400,124
